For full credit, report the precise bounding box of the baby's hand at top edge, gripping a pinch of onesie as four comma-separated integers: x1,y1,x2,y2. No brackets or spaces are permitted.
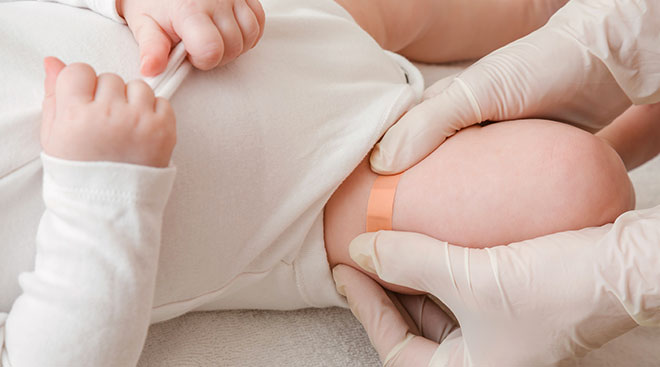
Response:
117,0,266,76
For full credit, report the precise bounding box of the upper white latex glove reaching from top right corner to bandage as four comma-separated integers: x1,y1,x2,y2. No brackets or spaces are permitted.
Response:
371,0,660,174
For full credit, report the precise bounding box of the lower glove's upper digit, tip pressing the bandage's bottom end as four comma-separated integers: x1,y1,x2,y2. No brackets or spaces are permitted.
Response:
349,231,462,298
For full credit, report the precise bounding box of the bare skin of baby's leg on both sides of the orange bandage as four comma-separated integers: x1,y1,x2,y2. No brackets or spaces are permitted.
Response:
324,120,635,293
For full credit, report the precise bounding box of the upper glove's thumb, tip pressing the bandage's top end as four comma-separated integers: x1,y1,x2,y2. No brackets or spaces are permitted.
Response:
370,78,483,175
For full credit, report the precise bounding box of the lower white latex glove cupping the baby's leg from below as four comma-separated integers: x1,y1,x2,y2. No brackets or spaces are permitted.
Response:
335,207,660,366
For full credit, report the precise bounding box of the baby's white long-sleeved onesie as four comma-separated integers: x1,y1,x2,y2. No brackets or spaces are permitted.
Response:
0,0,423,367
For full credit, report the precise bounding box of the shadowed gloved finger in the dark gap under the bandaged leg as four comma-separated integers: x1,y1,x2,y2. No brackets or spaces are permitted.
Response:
396,294,458,343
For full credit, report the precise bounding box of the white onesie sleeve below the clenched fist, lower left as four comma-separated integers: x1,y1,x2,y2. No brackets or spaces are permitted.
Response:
0,154,175,367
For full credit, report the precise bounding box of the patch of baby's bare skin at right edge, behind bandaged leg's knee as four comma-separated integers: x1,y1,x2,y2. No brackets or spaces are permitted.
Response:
596,103,660,170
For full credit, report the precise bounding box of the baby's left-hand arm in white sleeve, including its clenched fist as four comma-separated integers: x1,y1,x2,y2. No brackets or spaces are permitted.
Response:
0,59,176,367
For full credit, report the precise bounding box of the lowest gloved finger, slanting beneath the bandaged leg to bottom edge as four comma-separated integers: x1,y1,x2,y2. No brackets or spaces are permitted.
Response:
332,265,437,366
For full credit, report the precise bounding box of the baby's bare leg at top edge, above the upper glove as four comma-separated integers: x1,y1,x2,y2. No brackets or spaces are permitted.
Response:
336,0,568,63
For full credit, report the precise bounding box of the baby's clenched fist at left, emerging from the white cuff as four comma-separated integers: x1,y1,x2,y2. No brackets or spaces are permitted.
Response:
41,57,176,167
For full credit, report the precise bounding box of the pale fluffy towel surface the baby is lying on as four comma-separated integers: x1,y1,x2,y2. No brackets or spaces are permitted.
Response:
139,64,660,367
